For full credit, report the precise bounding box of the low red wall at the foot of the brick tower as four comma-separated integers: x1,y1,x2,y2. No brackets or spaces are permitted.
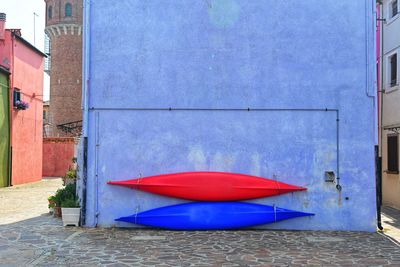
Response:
43,137,75,177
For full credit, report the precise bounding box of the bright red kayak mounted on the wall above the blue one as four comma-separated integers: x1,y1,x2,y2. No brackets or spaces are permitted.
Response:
108,172,307,201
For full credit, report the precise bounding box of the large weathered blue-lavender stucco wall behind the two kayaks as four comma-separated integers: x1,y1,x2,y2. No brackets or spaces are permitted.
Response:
84,0,377,231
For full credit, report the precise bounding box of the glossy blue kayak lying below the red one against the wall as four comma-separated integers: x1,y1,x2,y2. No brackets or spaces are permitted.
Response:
116,202,314,230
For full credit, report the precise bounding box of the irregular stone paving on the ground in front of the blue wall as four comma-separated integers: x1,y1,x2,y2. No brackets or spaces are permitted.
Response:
0,181,400,266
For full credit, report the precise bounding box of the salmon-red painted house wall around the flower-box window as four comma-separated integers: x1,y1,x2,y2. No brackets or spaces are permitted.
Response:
0,31,44,185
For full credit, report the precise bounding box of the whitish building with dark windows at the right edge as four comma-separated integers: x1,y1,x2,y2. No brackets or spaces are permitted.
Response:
380,0,400,208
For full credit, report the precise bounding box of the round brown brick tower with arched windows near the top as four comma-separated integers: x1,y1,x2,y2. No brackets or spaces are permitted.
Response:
44,0,83,136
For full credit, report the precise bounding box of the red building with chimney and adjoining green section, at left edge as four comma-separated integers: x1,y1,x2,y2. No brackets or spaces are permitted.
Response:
0,13,46,187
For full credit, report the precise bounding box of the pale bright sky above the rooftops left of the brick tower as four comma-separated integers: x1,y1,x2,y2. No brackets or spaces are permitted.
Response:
0,0,49,100
